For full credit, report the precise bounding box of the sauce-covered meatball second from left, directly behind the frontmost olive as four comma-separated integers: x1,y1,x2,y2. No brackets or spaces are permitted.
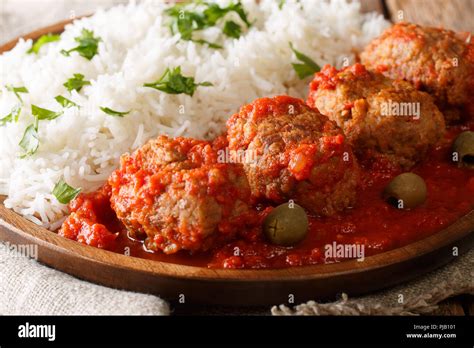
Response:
227,96,359,216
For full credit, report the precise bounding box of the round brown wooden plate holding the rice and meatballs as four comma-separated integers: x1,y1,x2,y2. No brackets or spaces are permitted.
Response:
0,21,474,306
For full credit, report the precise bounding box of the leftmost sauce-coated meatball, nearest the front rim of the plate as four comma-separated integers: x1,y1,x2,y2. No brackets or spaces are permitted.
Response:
109,136,254,254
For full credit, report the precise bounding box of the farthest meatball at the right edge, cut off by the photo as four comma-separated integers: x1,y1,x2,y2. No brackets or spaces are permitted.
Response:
361,23,474,123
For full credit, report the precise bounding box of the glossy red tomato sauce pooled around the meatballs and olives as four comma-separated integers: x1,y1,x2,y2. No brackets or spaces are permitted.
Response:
60,124,474,268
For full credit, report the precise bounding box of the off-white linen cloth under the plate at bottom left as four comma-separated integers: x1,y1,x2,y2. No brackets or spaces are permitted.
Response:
0,244,170,315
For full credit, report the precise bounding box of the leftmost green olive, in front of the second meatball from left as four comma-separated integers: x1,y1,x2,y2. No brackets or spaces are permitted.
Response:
263,203,308,246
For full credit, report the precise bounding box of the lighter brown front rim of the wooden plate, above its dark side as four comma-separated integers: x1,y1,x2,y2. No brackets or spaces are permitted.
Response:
0,204,474,282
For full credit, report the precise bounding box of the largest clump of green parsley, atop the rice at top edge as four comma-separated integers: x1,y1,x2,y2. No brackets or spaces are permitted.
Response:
165,1,251,48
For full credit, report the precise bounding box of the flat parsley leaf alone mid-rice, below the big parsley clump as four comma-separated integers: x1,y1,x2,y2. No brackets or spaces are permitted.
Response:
144,66,212,97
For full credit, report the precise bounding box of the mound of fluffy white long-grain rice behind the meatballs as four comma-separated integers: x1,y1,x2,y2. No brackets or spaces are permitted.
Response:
0,0,388,229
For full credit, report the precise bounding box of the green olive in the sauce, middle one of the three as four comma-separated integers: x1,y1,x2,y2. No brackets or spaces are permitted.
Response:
383,173,427,209
